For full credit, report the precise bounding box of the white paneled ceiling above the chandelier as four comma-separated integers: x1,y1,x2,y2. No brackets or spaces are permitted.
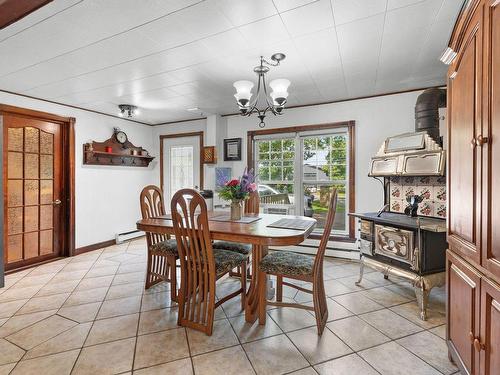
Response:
0,0,463,124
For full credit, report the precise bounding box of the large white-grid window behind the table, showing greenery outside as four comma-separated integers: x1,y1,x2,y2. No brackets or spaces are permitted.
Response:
253,126,354,236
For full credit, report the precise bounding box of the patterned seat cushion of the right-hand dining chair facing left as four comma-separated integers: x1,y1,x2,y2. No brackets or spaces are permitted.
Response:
259,251,314,276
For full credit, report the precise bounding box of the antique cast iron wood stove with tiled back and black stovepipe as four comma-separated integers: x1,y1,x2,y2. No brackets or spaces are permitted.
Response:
350,89,447,320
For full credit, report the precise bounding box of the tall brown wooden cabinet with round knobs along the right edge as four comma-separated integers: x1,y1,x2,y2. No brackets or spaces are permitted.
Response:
447,0,500,375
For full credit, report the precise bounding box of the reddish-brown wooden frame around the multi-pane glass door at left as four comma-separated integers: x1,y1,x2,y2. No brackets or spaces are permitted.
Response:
0,104,76,271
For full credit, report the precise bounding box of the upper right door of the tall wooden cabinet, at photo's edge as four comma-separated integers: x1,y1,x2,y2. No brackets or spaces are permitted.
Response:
481,0,500,282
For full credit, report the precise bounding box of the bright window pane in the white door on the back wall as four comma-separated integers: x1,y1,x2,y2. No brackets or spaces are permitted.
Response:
170,146,194,192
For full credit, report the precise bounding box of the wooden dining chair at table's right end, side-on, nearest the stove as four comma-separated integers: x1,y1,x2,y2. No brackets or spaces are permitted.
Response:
258,189,337,335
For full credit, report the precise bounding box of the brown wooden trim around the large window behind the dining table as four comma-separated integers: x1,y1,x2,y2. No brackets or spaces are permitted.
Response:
247,120,356,242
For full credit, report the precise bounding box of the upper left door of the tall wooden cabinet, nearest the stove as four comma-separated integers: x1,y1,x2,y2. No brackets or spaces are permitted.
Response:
448,6,483,264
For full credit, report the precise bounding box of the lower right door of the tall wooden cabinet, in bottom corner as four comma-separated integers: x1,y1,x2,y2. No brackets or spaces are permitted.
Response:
480,279,500,375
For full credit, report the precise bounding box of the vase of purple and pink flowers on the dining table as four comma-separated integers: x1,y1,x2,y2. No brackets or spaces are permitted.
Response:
219,168,257,221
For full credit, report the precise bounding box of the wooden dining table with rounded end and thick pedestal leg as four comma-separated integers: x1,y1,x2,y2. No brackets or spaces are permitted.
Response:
137,211,316,323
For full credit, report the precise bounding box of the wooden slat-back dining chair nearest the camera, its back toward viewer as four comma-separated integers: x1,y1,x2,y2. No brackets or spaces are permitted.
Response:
171,189,248,335
